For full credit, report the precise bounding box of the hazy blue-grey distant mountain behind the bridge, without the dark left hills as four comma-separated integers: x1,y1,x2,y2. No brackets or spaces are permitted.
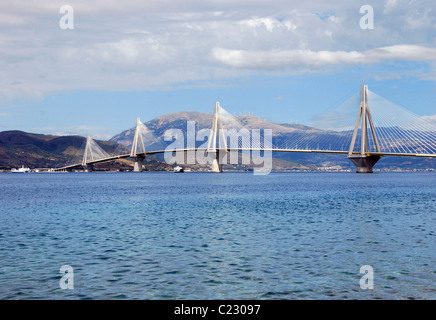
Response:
109,111,436,170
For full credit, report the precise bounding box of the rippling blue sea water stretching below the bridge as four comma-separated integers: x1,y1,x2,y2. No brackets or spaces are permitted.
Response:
0,172,436,299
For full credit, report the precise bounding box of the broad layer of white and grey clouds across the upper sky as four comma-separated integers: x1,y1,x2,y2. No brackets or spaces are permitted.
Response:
0,0,436,100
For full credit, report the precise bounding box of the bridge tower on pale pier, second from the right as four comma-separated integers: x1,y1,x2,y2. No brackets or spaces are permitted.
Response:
207,101,227,172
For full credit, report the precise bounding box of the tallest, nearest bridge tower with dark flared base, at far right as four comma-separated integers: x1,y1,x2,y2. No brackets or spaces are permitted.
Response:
348,85,380,173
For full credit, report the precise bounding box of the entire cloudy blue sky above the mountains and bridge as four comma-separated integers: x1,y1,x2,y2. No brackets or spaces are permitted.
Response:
0,0,436,139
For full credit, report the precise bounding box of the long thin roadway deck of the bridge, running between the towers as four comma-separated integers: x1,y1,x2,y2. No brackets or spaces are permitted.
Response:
55,148,436,171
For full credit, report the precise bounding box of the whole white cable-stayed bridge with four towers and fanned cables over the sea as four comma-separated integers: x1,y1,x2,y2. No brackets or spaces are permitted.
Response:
56,85,436,173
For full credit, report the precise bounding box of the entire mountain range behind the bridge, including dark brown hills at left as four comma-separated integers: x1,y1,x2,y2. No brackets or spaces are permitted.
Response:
0,111,436,170
